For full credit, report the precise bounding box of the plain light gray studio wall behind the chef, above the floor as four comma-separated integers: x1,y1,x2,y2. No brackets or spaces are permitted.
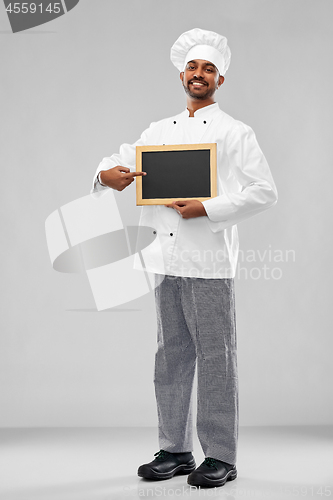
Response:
0,0,333,427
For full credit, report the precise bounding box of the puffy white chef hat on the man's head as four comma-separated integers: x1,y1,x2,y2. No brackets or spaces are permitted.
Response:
170,28,231,76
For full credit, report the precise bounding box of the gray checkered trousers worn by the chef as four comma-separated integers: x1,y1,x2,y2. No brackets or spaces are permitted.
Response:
154,276,238,464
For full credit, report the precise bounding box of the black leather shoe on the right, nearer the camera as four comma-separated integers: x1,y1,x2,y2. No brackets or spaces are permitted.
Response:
187,457,237,488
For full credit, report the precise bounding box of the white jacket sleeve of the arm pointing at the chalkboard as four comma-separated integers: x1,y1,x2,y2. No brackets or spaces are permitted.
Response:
90,123,155,193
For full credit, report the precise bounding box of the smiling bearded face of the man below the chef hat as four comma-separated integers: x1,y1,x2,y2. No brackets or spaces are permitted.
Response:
180,59,224,100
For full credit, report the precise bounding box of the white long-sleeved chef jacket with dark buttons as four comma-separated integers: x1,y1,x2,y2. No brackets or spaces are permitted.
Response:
92,103,277,279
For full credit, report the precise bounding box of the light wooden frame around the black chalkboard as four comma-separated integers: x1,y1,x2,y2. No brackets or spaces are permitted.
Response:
136,143,217,205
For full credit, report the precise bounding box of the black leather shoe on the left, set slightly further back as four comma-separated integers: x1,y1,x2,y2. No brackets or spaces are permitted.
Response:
138,450,196,479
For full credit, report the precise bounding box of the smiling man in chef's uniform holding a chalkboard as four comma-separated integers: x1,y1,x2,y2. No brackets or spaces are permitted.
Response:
94,28,277,487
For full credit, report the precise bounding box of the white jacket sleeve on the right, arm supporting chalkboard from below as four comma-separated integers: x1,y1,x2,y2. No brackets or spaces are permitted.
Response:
203,122,277,232
